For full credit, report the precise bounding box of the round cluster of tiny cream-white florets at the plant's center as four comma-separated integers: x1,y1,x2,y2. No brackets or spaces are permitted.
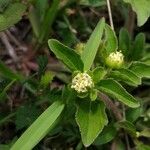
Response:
71,72,94,93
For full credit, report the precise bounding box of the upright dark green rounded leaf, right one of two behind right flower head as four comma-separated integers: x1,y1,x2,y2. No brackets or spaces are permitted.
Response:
131,33,145,60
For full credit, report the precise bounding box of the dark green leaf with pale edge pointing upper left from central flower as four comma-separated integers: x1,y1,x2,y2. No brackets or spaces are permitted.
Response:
48,39,83,71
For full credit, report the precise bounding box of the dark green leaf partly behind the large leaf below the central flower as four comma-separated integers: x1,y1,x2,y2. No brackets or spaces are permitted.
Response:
94,124,117,145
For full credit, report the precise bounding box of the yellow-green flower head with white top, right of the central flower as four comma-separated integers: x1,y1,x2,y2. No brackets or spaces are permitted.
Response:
105,51,124,69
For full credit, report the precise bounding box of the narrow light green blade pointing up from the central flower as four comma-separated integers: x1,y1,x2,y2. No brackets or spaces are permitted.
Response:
81,18,105,71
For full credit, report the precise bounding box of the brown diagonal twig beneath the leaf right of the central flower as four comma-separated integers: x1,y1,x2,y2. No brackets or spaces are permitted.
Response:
99,93,122,120
